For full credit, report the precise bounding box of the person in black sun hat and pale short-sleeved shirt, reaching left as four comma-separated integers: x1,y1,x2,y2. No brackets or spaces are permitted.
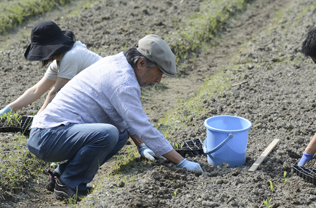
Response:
0,21,101,116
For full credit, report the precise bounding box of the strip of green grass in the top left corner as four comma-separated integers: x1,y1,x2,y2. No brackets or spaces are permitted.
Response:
0,0,72,34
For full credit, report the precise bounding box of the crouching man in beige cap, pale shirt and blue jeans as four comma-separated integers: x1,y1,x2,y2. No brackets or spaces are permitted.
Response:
27,35,202,200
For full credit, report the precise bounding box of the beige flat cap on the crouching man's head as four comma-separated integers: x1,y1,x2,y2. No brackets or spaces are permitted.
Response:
137,34,177,77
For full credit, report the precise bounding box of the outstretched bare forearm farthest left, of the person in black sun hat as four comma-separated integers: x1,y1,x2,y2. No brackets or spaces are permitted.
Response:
9,87,41,111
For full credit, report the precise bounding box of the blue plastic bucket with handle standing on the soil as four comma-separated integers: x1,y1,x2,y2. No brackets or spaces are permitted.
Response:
203,115,252,167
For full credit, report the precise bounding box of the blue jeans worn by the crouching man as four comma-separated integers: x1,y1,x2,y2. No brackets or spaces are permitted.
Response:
27,123,128,191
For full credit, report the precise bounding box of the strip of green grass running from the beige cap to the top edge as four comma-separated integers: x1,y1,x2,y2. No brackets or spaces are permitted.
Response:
168,0,251,64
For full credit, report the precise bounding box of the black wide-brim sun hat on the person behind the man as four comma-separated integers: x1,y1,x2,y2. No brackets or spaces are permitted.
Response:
24,21,76,61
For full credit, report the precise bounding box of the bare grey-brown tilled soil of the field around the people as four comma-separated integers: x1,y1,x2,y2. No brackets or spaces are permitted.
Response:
0,0,316,208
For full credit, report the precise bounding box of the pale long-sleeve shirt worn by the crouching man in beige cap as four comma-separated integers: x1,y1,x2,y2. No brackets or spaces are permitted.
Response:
32,52,173,156
